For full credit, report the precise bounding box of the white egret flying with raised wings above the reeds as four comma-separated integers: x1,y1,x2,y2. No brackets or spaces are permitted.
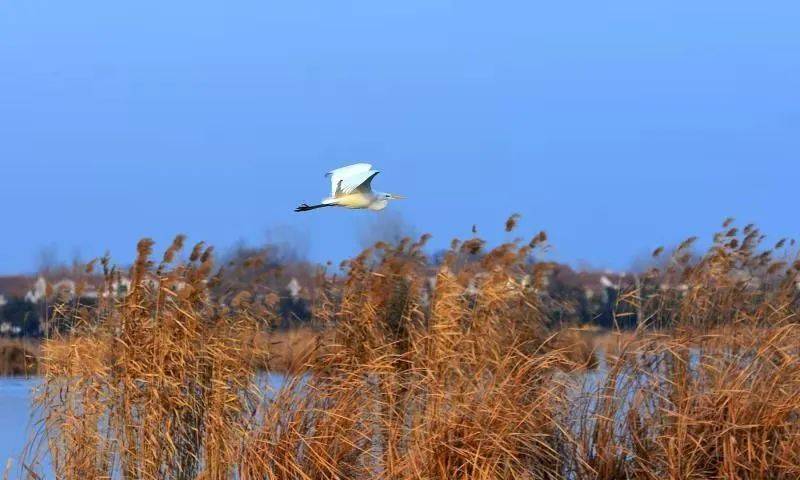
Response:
294,163,404,212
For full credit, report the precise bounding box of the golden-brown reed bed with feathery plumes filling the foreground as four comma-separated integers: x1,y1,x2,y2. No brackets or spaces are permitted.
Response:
21,216,800,479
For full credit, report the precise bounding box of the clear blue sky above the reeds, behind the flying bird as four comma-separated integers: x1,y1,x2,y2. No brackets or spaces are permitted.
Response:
0,0,800,273
